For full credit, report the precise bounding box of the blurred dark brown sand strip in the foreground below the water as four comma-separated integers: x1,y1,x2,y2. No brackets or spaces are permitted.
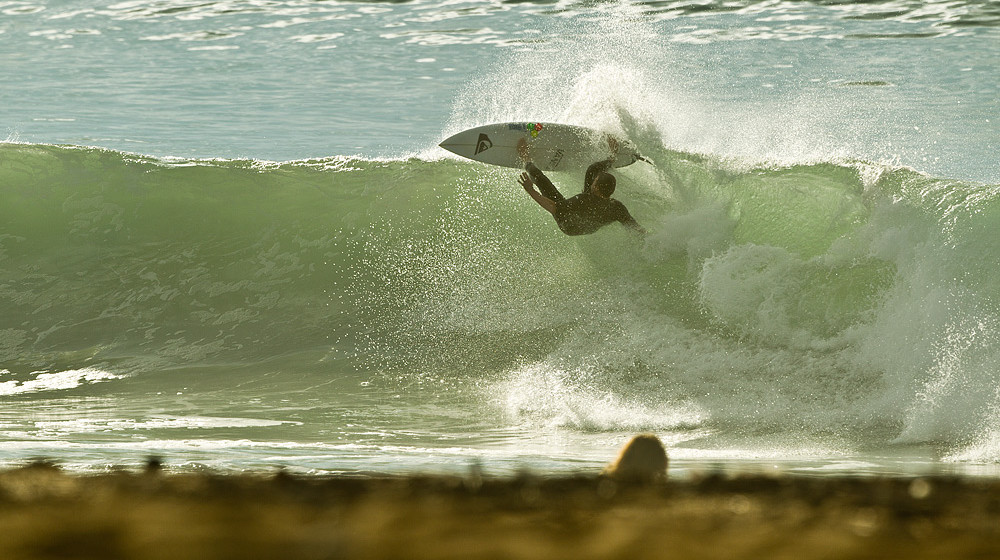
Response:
0,464,1000,560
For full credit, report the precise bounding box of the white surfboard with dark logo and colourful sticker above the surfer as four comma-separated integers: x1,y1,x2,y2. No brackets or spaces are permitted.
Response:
440,122,643,171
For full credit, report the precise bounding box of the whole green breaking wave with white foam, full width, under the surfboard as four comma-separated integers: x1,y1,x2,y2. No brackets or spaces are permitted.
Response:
0,140,1000,460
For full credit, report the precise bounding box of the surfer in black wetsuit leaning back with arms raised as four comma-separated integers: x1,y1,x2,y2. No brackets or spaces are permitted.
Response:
517,136,646,235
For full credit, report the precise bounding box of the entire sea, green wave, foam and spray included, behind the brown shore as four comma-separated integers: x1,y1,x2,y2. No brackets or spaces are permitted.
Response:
0,0,1000,476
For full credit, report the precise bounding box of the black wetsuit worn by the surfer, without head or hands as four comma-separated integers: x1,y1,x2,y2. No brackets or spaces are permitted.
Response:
525,161,639,235
